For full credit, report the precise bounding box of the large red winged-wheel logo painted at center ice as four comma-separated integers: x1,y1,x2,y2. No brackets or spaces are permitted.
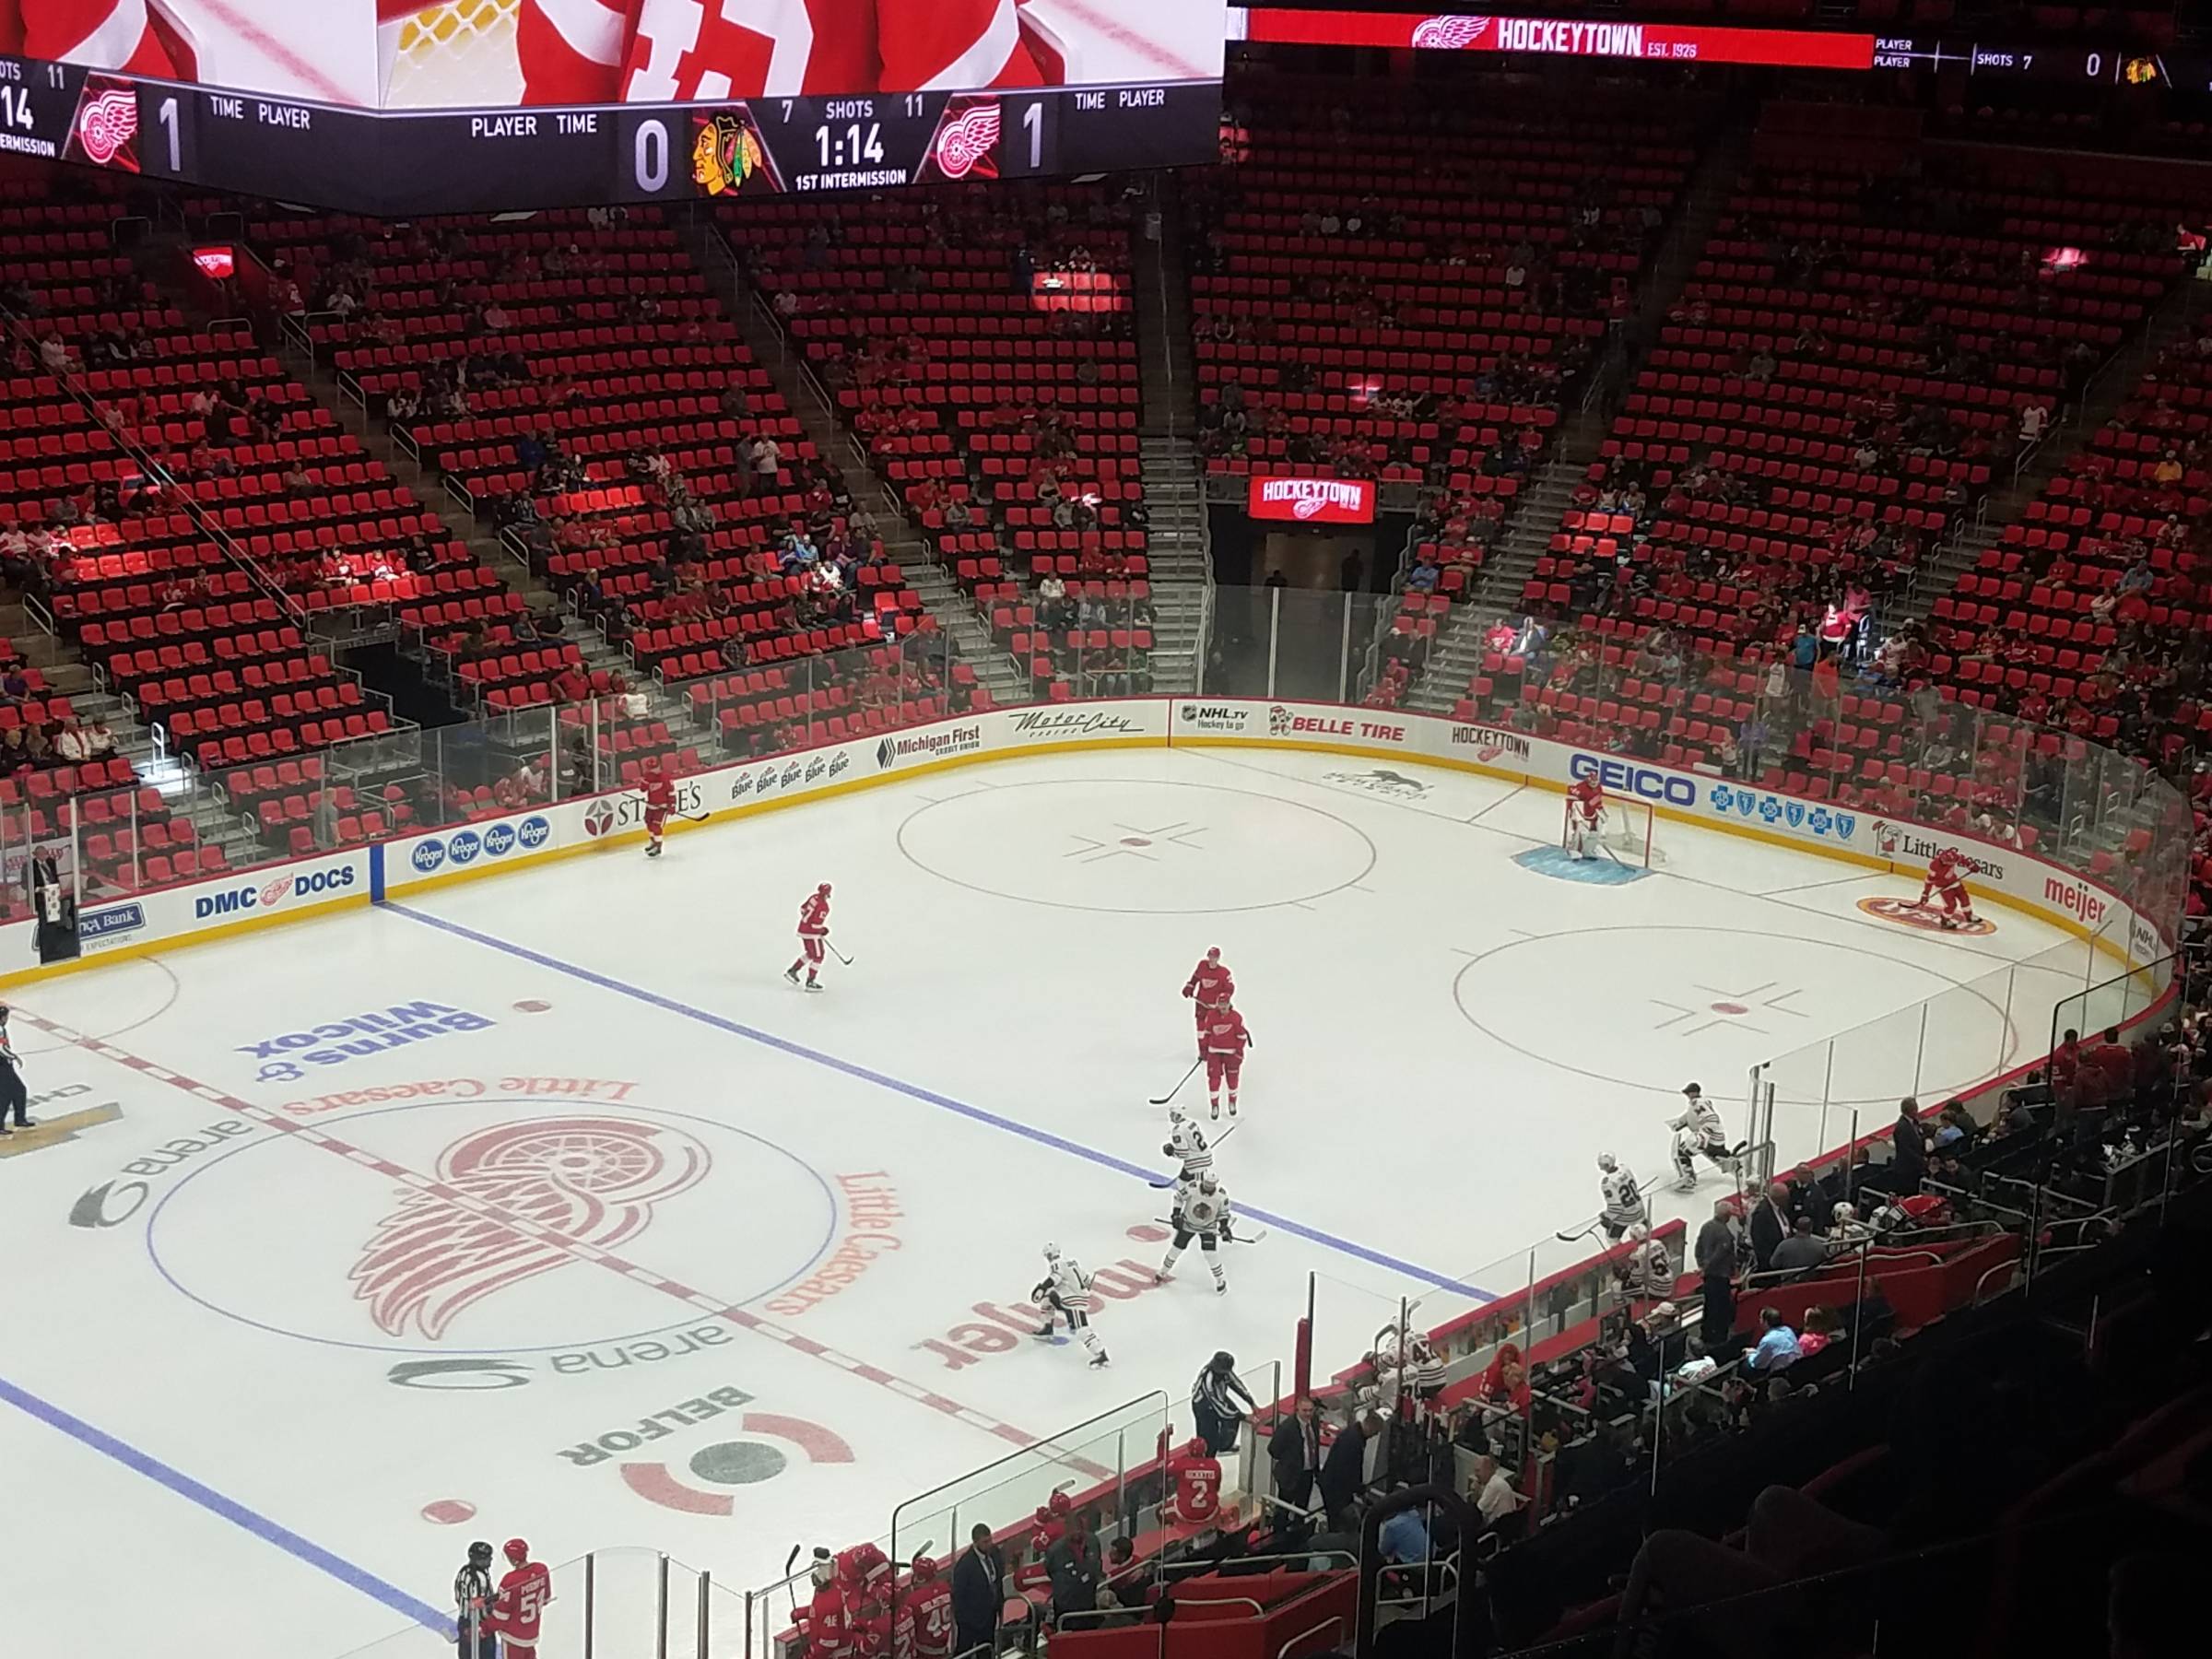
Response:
347,1117,712,1340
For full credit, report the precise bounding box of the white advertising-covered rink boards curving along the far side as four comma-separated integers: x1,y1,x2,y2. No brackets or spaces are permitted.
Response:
0,697,2172,984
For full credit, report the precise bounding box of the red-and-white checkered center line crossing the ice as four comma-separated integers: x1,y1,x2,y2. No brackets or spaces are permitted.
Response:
16,1008,1112,1480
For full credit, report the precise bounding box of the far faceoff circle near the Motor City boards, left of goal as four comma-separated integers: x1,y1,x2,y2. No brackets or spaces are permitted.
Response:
898,779,1376,916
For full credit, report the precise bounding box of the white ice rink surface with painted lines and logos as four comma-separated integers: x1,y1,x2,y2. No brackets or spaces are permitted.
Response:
0,750,2066,1659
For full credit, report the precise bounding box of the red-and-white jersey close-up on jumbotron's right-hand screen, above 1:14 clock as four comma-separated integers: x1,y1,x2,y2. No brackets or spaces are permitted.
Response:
515,0,1055,104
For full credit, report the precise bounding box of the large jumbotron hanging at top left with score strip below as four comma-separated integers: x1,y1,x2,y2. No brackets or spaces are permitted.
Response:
0,0,1226,215
